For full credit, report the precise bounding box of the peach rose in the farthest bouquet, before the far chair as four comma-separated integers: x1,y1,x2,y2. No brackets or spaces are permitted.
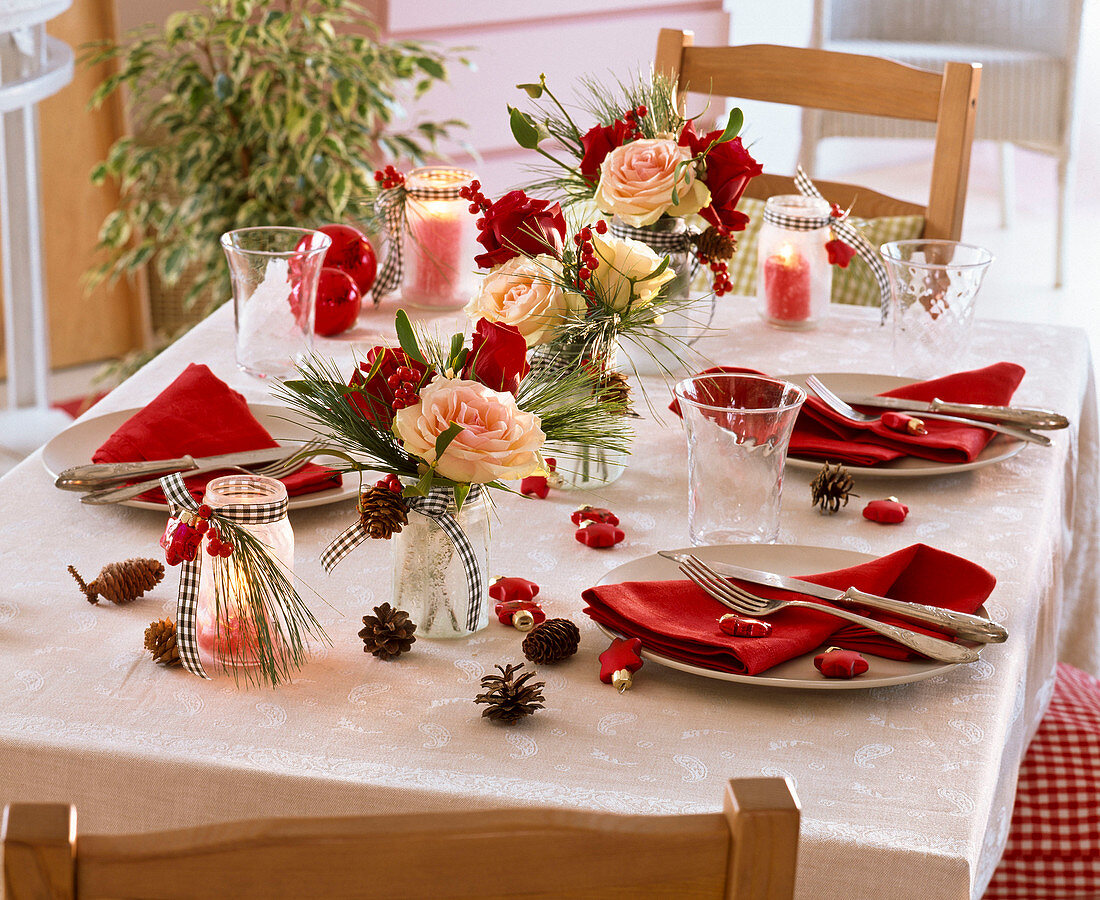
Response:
596,138,711,228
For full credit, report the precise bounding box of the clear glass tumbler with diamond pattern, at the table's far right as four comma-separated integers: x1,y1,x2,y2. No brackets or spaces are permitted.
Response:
879,240,993,378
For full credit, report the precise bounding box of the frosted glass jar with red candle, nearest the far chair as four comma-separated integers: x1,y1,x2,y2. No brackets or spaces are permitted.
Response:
757,194,833,329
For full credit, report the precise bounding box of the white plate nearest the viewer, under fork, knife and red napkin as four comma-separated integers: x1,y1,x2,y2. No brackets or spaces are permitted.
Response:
594,544,987,691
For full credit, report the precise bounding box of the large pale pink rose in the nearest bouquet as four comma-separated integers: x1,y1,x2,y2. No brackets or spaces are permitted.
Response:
394,375,546,484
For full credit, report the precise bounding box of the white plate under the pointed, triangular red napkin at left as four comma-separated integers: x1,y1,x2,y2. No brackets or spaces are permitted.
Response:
42,403,359,513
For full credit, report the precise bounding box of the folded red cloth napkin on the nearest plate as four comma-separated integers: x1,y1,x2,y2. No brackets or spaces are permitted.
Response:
582,544,997,674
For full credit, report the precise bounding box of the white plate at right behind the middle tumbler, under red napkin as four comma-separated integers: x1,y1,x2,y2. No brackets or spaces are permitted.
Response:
779,372,1027,479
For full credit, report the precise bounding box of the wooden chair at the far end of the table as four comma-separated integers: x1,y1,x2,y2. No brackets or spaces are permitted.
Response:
656,29,981,241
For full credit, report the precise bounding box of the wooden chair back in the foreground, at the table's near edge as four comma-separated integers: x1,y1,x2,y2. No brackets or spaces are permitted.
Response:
3,778,799,900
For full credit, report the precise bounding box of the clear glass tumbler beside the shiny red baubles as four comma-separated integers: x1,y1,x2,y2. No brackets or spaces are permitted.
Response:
221,228,332,378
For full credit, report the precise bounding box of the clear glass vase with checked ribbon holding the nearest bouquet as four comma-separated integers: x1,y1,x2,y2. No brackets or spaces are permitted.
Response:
391,496,490,638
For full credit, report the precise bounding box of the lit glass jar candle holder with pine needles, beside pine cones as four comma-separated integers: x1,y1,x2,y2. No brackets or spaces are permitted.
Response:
195,475,294,669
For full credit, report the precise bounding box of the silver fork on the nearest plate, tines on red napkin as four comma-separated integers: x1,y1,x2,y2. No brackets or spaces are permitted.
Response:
680,553,978,662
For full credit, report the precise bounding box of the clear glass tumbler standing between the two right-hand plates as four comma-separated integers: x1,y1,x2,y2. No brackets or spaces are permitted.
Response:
673,374,806,545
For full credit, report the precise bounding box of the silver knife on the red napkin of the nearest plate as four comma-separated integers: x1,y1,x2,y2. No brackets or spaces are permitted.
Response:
657,550,1009,644
